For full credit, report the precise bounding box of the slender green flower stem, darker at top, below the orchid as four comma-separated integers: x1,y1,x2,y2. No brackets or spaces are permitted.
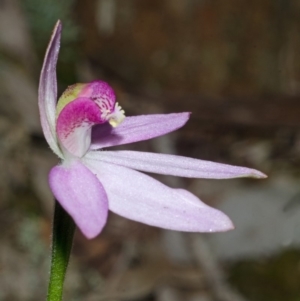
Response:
47,201,76,301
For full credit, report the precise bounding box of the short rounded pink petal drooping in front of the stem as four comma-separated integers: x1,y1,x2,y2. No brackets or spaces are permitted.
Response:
49,161,108,238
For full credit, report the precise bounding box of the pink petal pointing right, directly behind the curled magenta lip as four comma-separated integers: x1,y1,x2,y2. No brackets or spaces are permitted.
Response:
91,113,190,149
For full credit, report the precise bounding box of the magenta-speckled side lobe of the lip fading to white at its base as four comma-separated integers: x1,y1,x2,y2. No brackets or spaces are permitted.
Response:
56,97,103,157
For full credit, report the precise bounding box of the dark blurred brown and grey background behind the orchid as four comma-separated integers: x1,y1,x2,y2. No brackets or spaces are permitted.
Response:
0,0,300,301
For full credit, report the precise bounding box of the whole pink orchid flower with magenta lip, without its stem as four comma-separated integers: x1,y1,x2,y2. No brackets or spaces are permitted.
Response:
39,22,265,238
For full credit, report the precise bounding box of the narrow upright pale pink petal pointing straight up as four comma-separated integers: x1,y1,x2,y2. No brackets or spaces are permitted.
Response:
39,21,63,158
